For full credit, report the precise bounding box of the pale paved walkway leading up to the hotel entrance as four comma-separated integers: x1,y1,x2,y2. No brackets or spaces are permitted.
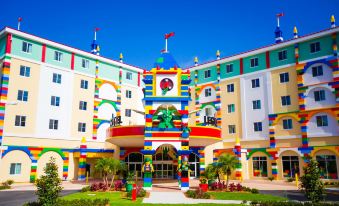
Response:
142,192,242,204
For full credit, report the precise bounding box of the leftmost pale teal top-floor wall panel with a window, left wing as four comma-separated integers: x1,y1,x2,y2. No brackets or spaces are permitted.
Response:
11,35,42,61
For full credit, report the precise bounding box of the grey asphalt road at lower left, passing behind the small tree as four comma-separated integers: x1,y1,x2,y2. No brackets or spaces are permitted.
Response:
0,190,79,206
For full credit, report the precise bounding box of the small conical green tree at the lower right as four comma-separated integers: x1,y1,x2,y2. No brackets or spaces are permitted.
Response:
300,159,324,202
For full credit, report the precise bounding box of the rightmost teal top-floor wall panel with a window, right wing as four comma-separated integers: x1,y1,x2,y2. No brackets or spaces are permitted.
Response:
299,35,332,61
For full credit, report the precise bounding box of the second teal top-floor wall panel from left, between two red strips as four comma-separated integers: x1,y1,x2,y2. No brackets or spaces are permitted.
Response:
46,45,72,69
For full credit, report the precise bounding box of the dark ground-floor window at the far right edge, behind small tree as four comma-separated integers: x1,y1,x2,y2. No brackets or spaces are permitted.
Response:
316,155,338,179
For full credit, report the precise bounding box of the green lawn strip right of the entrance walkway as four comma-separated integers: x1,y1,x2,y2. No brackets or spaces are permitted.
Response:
209,192,288,201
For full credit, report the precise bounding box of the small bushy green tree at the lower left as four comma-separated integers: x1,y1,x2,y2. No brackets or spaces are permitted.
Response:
35,157,62,206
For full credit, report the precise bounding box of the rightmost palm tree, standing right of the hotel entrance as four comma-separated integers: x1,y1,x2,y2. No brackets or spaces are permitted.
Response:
217,154,238,188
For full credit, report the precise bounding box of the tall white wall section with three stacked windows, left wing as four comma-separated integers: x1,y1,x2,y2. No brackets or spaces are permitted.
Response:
36,65,73,139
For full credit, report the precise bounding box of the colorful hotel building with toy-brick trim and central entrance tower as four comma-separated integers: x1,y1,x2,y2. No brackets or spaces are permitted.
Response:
0,18,339,188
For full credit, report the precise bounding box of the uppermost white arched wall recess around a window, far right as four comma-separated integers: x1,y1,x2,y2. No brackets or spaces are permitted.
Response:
303,63,333,86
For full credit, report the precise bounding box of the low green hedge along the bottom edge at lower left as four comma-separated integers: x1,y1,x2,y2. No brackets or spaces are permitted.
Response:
24,198,109,206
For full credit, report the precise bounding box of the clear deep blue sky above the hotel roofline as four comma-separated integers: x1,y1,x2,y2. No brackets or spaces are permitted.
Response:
0,0,339,69
